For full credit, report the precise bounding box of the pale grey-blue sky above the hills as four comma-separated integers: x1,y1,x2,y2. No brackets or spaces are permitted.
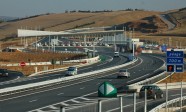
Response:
0,0,186,17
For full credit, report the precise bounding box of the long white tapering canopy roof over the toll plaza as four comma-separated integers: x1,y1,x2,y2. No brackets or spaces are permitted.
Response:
17,29,124,37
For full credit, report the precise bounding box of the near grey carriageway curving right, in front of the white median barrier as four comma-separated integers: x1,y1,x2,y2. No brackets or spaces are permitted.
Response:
0,52,164,112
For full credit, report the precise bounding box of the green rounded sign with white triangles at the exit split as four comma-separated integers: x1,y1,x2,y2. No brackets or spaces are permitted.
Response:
98,82,117,97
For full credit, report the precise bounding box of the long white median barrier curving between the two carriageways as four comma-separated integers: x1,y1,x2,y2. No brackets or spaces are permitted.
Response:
0,58,138,96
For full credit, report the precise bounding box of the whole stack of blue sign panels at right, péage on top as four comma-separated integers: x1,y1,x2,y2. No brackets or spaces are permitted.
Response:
166,51,184,72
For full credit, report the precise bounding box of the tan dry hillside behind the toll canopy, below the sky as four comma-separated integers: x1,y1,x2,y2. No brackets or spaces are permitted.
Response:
0,11,159,39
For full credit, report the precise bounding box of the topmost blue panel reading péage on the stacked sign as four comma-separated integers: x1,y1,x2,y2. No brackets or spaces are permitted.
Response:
167,51,184,58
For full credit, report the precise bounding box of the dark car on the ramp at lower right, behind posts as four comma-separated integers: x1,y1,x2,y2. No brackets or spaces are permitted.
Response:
139,85,163,99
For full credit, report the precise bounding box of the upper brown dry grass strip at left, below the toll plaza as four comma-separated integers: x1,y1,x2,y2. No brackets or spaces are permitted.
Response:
0,51,85,63
